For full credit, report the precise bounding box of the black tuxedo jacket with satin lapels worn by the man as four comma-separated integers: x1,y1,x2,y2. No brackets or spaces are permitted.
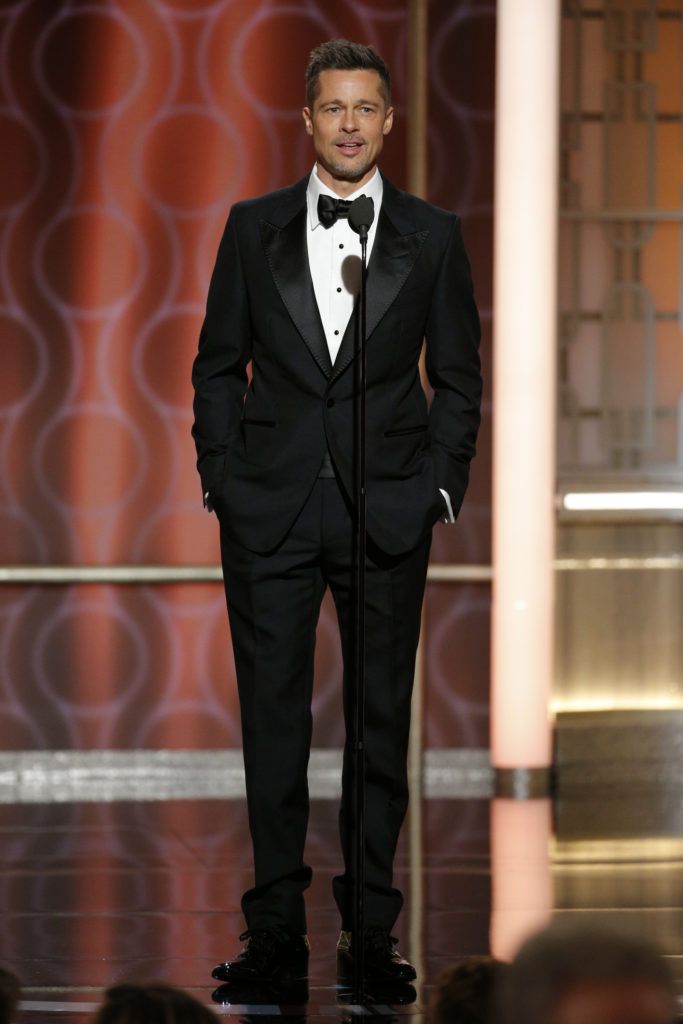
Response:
193,176,481,554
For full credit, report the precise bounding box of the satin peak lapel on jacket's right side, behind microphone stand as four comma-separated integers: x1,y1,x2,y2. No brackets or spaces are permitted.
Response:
332,202,429,380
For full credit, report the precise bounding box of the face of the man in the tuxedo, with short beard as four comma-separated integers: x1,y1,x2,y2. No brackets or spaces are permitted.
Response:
303,70,393,195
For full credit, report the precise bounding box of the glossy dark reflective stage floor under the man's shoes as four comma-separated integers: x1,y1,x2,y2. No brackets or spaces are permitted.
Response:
0,793,683,1024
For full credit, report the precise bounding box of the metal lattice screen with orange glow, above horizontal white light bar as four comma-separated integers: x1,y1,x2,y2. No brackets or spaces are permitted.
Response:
558,0,683,482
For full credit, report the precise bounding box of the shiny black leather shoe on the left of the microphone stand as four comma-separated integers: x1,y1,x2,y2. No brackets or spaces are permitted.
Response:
211,928,310,984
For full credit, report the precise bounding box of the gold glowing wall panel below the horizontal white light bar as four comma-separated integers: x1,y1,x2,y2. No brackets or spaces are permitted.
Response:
554,521,683,710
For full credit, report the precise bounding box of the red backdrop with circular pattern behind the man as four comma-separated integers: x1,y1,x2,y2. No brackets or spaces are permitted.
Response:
0,0,495,750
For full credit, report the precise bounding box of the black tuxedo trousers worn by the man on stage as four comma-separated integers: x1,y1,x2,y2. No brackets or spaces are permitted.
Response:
221,478,431,934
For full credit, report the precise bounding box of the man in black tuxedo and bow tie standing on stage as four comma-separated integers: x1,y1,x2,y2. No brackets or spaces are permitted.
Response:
193,40,481,981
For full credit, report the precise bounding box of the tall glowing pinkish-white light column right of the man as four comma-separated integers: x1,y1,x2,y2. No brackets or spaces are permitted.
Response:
492,0,560,782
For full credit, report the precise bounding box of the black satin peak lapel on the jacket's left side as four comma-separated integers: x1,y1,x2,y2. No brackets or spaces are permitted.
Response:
259,203,332,377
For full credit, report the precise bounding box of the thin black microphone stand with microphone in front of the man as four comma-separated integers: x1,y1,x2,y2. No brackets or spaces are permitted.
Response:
348,196,375,1005
